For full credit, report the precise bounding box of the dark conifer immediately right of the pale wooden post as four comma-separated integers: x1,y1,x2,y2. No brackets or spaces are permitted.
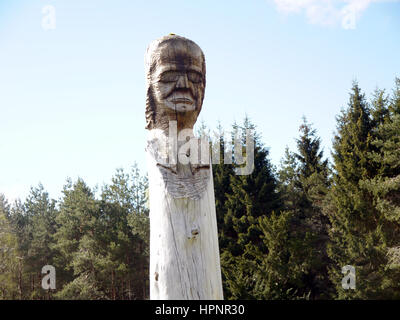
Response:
221,117,280,299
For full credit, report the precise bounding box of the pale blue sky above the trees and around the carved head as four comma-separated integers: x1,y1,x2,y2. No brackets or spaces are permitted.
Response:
0,0,400,201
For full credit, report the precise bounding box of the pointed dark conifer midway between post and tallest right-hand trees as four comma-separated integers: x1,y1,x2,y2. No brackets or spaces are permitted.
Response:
270,118,332,299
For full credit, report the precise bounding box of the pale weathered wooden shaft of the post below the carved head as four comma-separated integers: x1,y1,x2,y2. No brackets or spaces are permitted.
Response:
147,133,223,300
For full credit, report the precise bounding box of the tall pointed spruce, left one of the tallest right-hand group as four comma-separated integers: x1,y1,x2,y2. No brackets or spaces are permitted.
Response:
326,83,385,299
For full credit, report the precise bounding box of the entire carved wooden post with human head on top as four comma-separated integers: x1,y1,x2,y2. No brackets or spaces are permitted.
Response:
146,35,223,300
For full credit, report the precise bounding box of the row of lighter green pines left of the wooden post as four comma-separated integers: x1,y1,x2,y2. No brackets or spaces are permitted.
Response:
0,165,149,299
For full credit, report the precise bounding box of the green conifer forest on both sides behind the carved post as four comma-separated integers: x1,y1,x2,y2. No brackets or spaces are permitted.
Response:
0,78,400,300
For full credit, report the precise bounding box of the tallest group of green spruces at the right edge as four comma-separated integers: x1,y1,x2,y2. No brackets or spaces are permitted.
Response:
327,79,400,299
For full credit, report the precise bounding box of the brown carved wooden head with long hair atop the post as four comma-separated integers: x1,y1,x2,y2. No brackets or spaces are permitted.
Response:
145,34,206,130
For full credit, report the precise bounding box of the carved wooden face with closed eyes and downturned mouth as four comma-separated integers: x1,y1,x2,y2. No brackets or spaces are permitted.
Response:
152,40,205,113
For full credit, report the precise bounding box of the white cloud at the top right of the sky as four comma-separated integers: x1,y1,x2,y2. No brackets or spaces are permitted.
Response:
274,0,399,29
